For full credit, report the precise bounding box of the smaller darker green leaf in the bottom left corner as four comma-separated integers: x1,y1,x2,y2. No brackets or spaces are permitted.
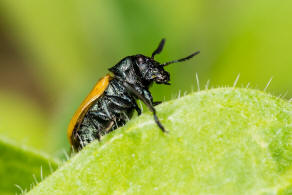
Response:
0,137,58,195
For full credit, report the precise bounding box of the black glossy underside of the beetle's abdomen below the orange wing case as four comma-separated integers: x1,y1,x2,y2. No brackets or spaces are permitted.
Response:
72,79,136,150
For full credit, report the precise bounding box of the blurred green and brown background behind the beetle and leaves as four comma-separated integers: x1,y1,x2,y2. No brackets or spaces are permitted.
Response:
0,0,292,156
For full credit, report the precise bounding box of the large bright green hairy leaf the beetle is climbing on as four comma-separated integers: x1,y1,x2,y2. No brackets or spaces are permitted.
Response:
29,88,292,194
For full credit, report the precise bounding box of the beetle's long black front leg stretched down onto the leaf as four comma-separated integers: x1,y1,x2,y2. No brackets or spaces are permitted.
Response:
123,81,167,132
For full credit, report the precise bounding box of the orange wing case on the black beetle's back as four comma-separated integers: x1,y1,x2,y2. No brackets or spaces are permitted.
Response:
67,74,112,144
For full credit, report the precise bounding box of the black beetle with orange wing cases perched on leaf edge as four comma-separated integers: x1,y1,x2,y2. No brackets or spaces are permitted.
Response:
67,39,200,151
